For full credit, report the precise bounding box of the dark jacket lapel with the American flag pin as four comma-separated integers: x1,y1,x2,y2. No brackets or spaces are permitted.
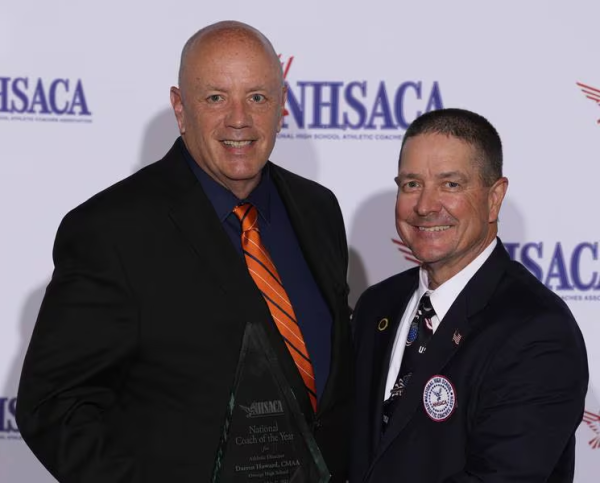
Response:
373,240,510,464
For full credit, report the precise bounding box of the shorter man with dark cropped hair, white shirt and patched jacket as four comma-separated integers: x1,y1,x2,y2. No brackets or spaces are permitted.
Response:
350,109,588,483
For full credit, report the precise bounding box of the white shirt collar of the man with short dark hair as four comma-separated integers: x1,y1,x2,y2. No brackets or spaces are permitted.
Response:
418,238,498,322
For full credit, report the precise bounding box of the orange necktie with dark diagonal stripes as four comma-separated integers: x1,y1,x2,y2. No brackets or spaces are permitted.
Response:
233,203,317,411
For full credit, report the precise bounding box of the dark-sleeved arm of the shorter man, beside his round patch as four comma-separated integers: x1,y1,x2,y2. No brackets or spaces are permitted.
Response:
446,313,588,483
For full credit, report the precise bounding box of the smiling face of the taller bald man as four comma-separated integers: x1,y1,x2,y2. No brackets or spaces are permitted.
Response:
171,30,285,199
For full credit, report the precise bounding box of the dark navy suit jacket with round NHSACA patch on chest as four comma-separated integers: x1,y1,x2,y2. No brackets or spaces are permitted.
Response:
350,242,588,483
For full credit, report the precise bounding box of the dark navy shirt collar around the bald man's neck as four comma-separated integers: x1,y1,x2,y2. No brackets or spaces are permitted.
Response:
179,137,273,223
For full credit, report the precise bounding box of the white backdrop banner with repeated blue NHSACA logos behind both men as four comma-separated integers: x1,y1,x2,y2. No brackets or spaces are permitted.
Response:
0,0,600,483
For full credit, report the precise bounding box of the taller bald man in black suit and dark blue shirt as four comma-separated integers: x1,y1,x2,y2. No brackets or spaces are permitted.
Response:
17,22,352,483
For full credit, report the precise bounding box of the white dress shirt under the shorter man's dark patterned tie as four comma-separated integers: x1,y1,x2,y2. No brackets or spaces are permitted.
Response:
384,238,497,400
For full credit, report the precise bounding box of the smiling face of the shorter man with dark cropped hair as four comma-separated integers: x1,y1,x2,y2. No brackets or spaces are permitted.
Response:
396,134,508,288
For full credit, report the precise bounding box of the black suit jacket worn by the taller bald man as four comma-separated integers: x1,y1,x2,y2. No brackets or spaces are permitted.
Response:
17,144,352,483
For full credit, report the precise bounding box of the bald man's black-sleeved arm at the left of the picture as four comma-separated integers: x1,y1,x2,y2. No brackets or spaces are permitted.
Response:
17,210,137,483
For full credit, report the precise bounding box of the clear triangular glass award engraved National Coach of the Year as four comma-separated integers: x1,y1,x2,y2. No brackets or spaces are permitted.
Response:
212,322,330,483
